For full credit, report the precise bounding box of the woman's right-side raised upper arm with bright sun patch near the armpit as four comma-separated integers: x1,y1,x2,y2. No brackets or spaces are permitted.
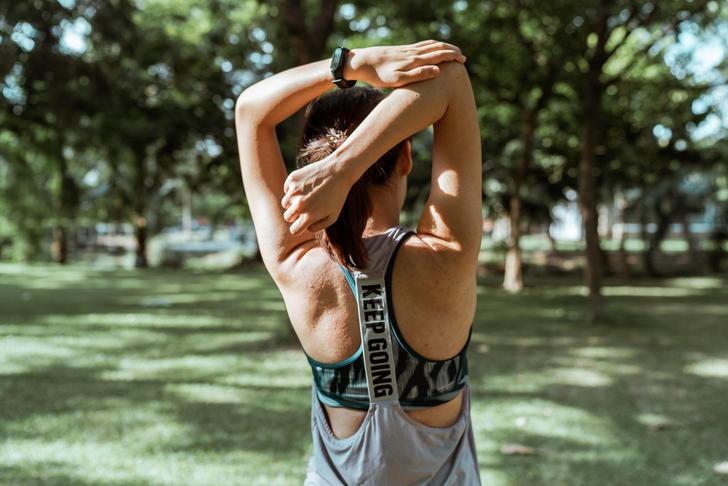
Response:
417,63,483,265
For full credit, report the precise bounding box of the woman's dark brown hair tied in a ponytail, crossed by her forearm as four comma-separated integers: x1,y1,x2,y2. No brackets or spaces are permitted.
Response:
296,86,407,269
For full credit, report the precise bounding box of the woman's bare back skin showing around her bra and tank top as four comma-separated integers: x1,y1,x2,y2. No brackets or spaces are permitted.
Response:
282,230,476,438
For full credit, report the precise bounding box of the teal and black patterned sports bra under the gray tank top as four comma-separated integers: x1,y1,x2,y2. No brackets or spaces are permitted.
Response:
304,225,472,410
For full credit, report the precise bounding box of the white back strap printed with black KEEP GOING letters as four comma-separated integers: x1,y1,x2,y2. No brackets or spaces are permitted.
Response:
354,271,399,402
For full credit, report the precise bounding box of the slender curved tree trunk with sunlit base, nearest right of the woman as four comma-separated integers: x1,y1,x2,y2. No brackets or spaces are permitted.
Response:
503,110,536,293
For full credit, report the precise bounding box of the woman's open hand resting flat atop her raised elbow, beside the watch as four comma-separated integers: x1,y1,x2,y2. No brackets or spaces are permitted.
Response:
344,40,465,88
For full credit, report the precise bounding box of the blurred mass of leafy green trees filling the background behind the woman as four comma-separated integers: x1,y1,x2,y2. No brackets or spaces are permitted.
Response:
0,0,728,319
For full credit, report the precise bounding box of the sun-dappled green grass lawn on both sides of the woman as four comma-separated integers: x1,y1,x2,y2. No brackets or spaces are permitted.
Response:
0,264,728,486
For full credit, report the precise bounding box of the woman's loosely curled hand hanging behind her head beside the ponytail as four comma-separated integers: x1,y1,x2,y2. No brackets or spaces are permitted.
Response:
281,153,353,235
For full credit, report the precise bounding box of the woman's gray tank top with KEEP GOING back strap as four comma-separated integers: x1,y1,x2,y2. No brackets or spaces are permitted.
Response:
304,225,480,486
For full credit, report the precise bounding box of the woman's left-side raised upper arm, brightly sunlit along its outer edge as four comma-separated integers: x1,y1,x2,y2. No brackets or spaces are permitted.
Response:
235,98,316,281
